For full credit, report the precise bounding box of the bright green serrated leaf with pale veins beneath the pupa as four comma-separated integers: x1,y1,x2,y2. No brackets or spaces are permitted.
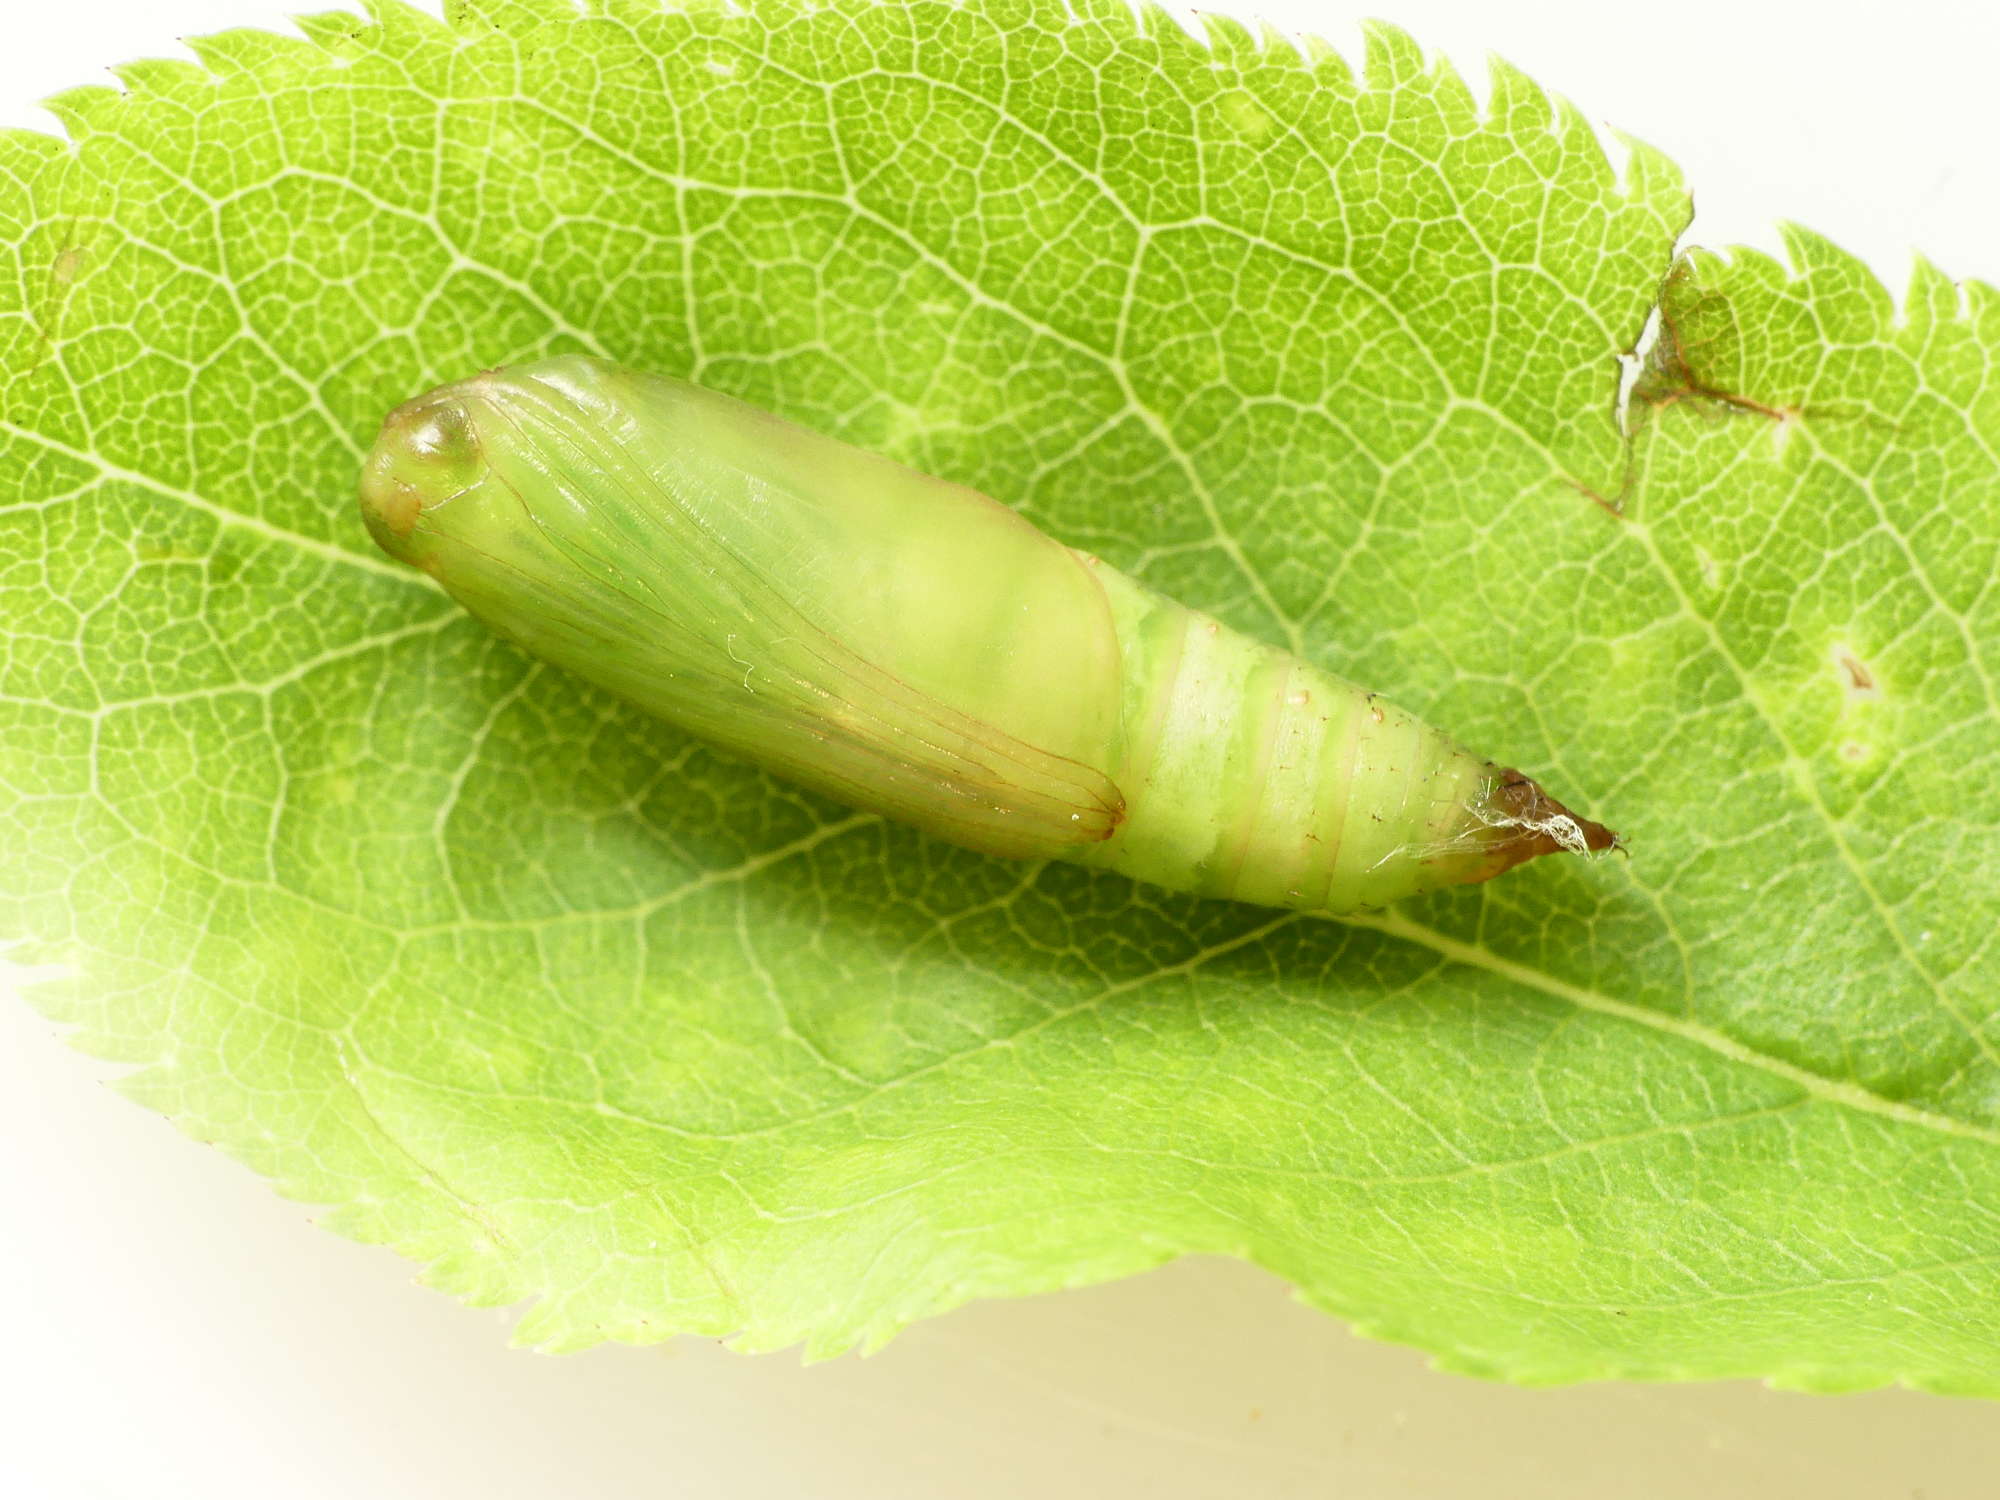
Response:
0,0,2000,1394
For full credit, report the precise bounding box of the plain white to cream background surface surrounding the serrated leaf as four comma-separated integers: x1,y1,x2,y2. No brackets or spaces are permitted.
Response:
0,0,2000,1500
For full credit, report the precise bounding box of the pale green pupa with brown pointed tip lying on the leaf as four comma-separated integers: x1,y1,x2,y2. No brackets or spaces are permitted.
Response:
362,356,1616,912
